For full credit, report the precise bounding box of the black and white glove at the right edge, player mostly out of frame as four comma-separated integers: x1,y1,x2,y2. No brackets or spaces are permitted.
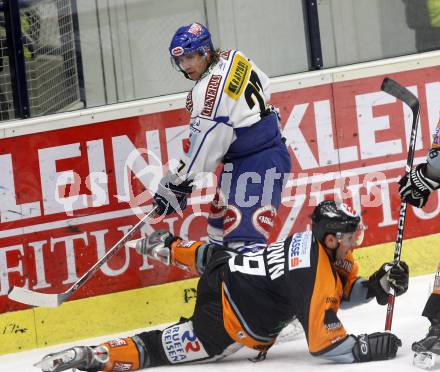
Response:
399,163,440,208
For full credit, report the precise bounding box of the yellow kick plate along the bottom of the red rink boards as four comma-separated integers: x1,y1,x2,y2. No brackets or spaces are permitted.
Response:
0,234,440,355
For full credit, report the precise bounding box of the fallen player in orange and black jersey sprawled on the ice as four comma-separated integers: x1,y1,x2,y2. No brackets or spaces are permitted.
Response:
37,201,408,372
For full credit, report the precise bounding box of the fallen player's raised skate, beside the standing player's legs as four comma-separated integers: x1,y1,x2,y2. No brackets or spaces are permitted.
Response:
135,230,180,265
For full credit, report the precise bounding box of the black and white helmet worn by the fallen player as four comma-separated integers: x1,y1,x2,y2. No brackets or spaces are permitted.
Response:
312,200,364,245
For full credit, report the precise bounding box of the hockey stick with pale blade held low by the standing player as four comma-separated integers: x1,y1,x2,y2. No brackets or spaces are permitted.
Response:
8,208,156,307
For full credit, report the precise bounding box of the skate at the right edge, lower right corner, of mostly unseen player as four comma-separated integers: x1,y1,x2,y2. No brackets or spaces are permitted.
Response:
411,324,440,369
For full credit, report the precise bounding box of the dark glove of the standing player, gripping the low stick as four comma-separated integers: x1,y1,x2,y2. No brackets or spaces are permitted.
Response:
154,175,192,215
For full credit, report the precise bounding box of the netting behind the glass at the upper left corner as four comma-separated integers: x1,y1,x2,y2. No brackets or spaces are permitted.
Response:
0,0,81,120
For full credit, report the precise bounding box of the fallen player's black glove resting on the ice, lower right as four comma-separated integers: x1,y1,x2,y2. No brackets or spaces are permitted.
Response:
353,332,402,363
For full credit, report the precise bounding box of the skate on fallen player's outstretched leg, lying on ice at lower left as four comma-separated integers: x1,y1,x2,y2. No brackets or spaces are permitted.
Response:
34,346,108,372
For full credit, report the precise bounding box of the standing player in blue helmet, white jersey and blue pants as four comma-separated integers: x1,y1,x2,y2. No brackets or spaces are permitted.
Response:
154,22,291,249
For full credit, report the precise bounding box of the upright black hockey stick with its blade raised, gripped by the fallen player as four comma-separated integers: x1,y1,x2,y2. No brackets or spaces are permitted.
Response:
380,78,420,331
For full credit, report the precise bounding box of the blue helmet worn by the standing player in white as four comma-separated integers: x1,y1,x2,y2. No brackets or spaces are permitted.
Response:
169,22,214,63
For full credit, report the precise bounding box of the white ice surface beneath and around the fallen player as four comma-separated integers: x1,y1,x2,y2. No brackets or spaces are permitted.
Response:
0,275,440,372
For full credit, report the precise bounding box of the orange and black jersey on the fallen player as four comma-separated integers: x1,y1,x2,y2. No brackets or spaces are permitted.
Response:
222,231,368,354
